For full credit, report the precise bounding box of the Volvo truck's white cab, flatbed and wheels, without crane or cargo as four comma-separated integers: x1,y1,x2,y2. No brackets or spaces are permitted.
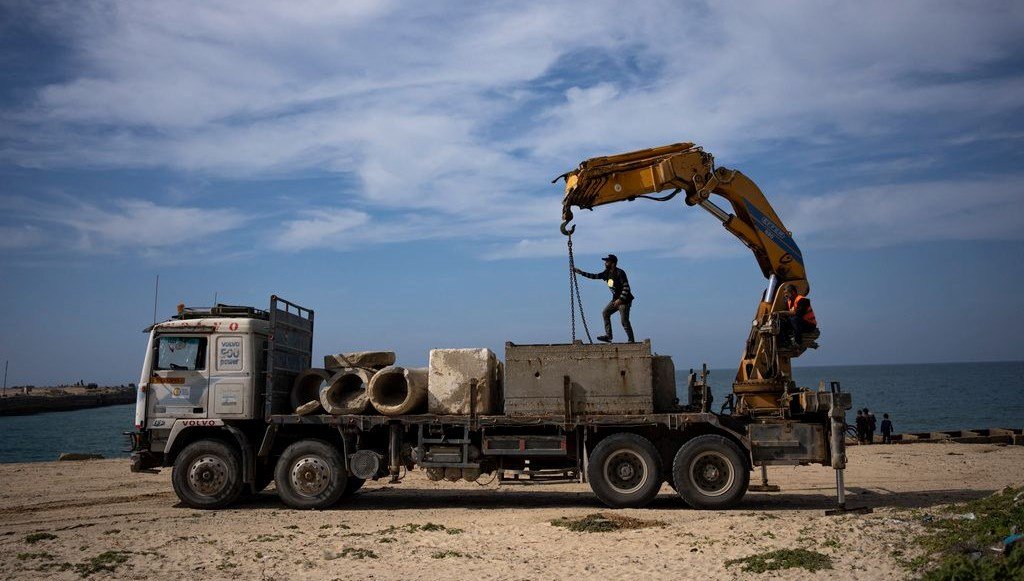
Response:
131,296,851,508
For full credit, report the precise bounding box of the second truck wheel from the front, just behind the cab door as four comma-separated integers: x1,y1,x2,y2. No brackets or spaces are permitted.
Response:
274,440,348,509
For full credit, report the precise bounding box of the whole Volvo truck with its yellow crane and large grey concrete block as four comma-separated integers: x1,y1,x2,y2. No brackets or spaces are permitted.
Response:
129,143,852,510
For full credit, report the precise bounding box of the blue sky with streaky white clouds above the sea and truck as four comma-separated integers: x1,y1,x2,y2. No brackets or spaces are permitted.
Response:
0,0,1024,385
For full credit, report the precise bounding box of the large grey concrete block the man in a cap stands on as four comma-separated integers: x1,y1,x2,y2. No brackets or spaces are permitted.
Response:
505,340,654,416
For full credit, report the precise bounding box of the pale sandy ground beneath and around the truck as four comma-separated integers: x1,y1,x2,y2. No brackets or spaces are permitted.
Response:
0,444,1024,579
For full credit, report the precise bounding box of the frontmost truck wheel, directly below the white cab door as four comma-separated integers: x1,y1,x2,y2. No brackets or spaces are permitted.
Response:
171,440,242,509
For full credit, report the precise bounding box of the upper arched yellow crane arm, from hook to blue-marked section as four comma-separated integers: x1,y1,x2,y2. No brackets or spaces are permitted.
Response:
560,143,807,284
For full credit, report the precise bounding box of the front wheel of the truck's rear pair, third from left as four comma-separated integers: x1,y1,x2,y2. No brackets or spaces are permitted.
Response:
587,433,662,508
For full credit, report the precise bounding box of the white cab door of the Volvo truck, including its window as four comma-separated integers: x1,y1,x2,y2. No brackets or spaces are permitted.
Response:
150,334,210,418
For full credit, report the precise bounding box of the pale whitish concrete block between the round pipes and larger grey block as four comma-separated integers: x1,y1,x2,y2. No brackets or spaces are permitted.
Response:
427,349,502,415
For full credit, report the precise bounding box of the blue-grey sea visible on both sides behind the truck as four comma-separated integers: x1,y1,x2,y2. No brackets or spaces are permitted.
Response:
0,362,1024,463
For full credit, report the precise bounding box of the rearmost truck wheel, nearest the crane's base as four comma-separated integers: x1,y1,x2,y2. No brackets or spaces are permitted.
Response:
672,434,751,508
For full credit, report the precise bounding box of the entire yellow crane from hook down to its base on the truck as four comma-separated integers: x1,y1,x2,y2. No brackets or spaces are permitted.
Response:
559,142,816,415
